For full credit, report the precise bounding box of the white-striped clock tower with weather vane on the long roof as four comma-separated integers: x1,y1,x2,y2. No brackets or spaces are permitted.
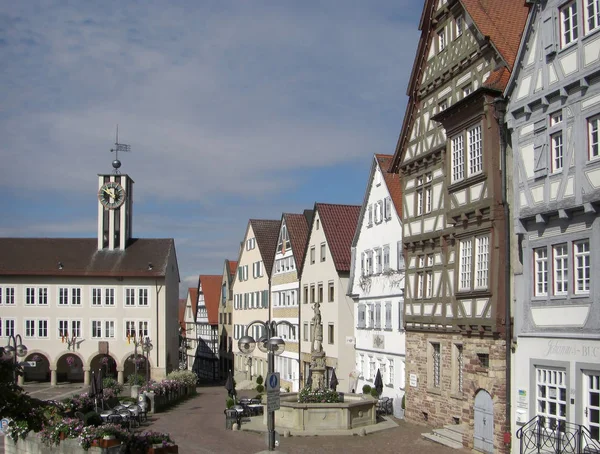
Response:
98,140,134,251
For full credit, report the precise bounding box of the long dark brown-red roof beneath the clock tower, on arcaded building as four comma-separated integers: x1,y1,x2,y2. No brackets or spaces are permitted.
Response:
0,238,175,277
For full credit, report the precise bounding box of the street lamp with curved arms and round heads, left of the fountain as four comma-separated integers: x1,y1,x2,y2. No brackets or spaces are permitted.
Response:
238,320,296,451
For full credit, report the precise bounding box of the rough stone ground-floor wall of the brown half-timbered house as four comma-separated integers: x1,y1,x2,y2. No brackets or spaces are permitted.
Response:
405,332,510,453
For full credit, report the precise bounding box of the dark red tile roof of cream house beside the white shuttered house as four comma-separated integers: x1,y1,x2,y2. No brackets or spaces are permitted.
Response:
315,203,361,272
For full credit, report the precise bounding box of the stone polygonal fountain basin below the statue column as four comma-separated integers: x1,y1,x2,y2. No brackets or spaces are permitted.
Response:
265,393,377,433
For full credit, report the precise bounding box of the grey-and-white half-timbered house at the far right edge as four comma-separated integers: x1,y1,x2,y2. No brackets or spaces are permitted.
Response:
507,0,600,452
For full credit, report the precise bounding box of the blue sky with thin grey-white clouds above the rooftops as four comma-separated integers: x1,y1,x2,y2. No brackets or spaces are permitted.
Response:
0,0,423,297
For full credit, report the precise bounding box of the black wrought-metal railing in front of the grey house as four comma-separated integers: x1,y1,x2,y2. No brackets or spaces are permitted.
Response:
517,416,600,454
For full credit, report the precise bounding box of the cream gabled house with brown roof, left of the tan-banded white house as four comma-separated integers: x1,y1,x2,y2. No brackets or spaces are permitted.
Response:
232,219,280,382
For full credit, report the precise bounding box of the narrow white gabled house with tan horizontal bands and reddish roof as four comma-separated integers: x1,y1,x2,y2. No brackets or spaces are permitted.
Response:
271,210,312,392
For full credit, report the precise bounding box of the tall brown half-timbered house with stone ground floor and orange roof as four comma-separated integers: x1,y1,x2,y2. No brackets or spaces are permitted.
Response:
391,0,528,452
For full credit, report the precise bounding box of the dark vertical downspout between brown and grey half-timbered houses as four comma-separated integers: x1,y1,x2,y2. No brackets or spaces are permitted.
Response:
494,97,512,445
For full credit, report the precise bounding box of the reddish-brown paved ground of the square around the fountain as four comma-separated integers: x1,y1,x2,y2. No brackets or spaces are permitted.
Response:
143,386,466,454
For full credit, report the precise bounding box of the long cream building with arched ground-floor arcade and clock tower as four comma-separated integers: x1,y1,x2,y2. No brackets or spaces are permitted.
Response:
0,164,179,385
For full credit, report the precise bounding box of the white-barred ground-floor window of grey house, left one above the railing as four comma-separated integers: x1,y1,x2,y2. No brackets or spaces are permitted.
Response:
535,367,567,429
